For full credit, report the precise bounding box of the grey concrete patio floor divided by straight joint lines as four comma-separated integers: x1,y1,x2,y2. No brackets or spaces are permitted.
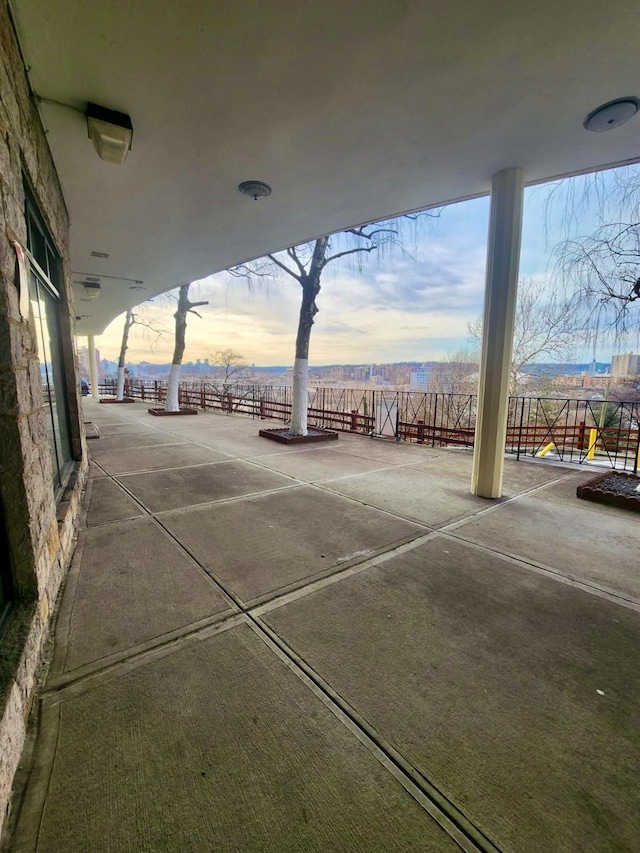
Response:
4,399,640,853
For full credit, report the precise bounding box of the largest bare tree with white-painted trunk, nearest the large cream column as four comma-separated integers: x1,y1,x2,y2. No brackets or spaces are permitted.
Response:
229,216,439,435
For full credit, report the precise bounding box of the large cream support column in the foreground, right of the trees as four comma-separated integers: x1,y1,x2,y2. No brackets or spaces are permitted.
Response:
471,169,524,498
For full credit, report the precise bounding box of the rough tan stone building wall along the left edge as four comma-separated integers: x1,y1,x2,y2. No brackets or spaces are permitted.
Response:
0,0,87,825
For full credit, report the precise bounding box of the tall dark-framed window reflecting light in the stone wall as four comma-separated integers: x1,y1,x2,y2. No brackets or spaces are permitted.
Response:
26,187,73,491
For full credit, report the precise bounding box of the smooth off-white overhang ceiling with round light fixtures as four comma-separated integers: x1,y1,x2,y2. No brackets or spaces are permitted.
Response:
8,0,640,334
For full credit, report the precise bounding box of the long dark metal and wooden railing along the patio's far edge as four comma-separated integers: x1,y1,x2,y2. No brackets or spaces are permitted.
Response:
100,378,640,473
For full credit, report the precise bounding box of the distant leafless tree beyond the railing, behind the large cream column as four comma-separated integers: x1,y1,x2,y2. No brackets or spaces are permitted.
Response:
468,278,584,396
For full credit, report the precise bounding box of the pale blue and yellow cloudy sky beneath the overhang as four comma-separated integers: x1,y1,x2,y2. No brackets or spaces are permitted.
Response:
94,167,636,365
